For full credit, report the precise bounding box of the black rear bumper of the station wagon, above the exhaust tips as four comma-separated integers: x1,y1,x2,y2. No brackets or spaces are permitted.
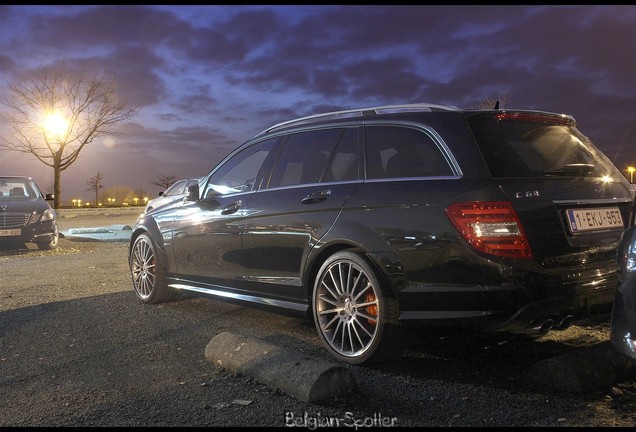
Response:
399,263,618,334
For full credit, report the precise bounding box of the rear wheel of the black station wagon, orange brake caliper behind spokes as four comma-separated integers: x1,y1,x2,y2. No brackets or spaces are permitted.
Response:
312,251,401,364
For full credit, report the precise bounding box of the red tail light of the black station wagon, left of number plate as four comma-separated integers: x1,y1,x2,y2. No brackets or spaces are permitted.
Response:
446,201,532,259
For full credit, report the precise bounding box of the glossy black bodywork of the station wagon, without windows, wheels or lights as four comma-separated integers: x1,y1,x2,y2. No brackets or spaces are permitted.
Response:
131,106,634,333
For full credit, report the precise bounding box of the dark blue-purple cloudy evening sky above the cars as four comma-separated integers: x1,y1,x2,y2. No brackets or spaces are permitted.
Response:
0,5,636,201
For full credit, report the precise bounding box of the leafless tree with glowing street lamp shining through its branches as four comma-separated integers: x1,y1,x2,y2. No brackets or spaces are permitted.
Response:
0,64,138,209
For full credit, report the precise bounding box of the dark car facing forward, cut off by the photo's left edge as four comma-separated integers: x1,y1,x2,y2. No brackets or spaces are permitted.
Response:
0,176,59,249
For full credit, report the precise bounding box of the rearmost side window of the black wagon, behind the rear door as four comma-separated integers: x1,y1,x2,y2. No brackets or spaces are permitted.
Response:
365,125,452,179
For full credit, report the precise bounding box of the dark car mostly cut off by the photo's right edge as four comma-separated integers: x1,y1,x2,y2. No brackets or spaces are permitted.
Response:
610,199,636,360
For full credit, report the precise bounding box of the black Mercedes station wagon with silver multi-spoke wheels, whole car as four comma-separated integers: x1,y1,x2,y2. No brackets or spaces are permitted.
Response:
129,104,635,364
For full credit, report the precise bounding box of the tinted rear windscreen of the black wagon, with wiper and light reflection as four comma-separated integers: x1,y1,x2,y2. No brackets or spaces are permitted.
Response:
468,115,613,177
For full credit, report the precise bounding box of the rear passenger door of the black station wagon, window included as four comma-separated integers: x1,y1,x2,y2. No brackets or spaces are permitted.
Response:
242,127,360,300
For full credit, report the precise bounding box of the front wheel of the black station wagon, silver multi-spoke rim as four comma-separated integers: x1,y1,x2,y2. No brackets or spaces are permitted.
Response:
128,233,175,304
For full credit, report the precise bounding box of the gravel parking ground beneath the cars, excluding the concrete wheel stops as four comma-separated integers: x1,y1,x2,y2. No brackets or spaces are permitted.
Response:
0,213,636,429
